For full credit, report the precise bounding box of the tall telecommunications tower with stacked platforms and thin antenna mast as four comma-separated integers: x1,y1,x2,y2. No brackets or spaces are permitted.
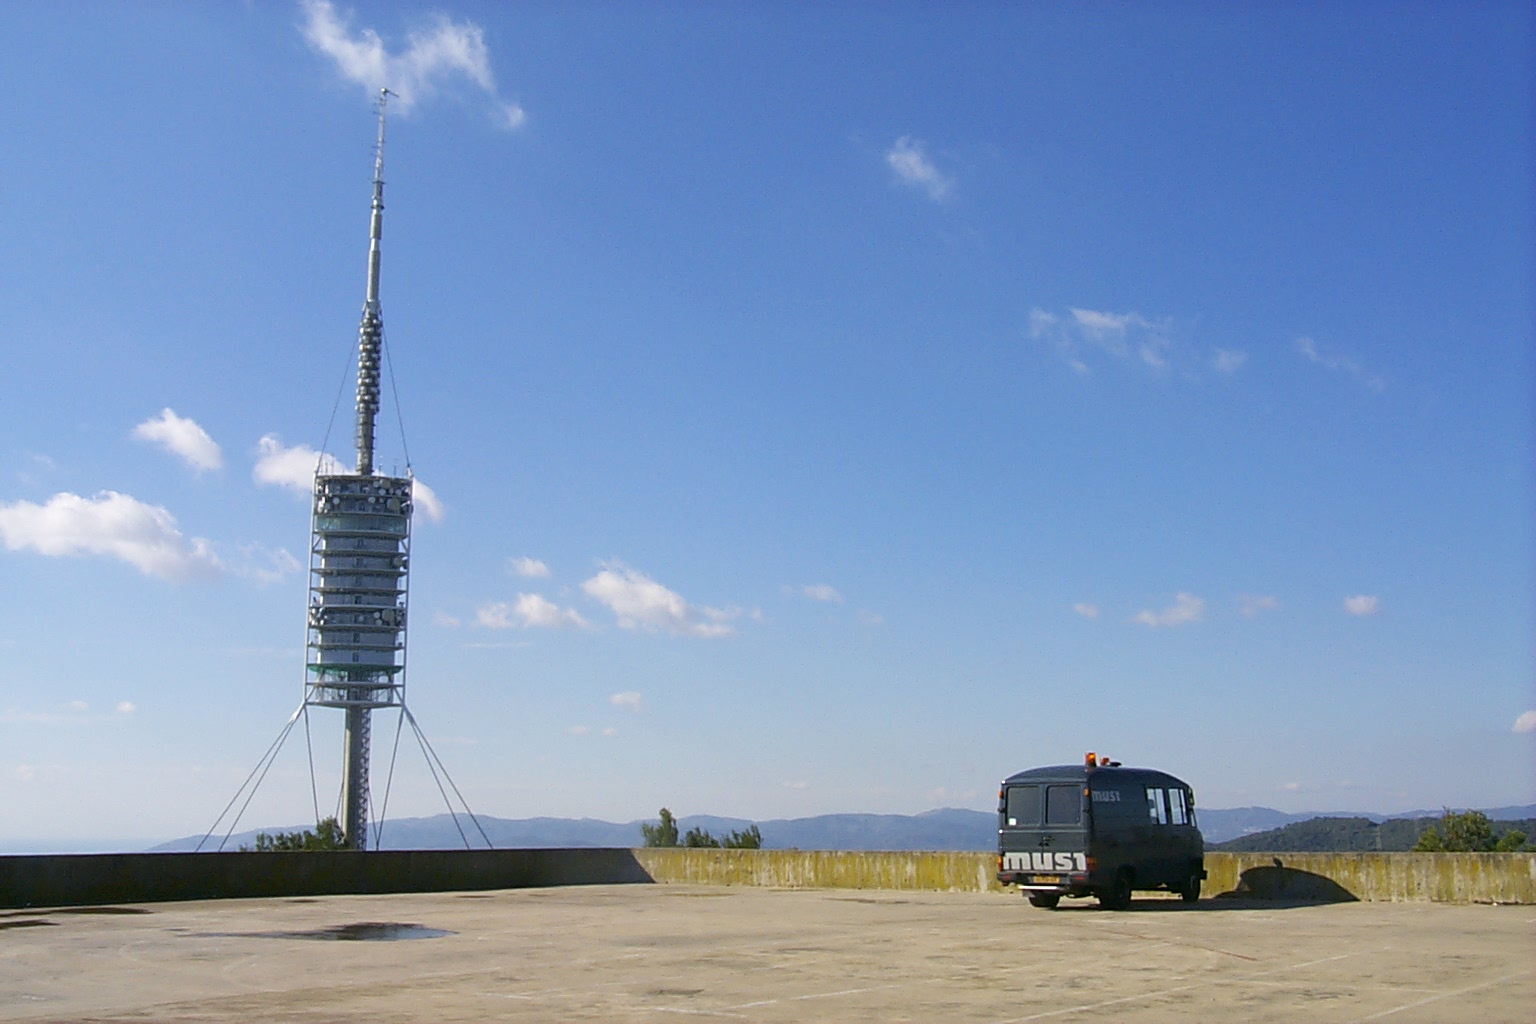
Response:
304,89,412,851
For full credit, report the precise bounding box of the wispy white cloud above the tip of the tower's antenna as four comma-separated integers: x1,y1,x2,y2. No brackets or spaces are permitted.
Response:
304,0,527,129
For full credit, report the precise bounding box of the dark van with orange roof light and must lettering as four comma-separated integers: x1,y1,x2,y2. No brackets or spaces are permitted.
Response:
997,754,1206,910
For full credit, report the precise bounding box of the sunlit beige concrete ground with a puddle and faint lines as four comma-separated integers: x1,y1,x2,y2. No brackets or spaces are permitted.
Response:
0,886,1536,1024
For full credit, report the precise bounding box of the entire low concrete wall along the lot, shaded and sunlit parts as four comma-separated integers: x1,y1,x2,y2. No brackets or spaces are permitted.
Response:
0,849,1536,907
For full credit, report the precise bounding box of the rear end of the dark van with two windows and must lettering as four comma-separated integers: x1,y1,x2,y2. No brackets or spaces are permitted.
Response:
998,780,1087,887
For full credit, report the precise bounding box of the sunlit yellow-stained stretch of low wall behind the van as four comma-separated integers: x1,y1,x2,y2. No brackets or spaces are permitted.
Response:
634,849,1536,903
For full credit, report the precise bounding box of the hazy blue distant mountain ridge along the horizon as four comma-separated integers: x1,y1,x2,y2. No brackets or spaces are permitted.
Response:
152,804,1536,852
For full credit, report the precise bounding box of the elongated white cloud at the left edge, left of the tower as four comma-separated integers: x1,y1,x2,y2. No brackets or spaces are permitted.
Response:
0,491,221,582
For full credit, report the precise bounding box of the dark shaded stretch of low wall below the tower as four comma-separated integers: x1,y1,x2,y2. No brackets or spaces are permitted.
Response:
0,849,651,907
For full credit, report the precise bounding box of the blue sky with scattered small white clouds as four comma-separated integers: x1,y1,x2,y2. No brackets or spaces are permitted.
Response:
0,3,1536,846
